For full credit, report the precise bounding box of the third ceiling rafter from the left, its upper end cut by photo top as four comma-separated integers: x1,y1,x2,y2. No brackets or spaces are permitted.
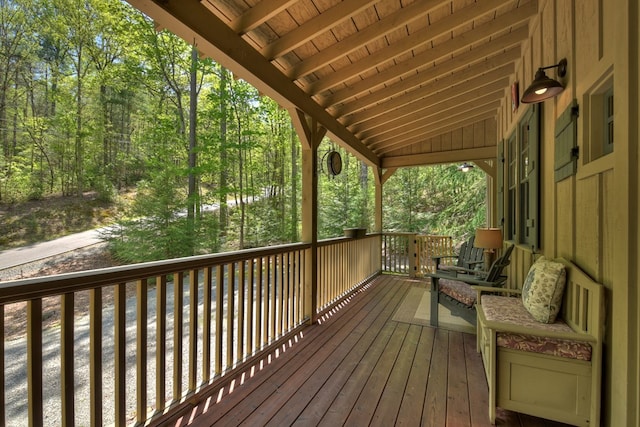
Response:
285,0,450,80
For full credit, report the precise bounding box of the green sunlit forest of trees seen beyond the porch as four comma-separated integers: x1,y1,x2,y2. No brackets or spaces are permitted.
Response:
0,0,486,262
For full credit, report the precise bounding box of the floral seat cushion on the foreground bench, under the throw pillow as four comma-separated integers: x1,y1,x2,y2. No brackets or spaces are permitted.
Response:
481,295,591,361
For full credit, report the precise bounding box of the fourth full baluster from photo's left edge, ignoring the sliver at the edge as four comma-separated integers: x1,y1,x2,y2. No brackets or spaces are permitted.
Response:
113,283,127,427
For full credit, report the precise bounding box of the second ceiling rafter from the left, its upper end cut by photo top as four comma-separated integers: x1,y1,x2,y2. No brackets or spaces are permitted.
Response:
261,0,375,60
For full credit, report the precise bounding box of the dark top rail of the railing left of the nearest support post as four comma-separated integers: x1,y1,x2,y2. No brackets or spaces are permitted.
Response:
0,243,311,304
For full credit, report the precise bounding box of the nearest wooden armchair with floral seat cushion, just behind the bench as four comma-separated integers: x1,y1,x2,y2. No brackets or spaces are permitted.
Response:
425,245,513,327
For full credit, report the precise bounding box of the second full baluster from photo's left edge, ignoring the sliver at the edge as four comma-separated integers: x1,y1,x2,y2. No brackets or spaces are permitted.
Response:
60,292,75,426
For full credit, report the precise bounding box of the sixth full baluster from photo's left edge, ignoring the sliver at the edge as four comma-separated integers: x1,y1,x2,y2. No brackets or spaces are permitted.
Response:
156,274,167,411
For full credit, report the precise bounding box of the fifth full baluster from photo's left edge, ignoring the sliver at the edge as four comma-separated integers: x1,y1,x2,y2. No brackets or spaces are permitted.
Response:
136,279,147,423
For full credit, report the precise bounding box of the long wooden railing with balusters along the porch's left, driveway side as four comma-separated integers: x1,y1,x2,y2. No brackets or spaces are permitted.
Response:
0,235,381,426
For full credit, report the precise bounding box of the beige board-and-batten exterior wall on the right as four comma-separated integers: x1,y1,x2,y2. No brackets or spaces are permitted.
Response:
498,0,640,426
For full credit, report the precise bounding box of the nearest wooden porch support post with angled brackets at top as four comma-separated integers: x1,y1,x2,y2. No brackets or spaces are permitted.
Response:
290,110,327,323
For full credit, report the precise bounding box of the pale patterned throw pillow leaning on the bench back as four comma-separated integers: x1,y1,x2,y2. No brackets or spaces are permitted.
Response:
522,257,567,323
